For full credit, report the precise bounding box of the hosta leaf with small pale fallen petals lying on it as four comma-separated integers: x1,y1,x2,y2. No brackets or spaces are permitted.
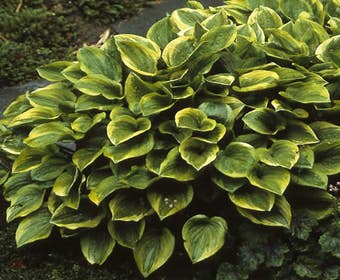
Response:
147,180,194,220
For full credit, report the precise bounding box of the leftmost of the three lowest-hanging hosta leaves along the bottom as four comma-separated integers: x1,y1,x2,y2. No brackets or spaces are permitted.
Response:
80,229,116,265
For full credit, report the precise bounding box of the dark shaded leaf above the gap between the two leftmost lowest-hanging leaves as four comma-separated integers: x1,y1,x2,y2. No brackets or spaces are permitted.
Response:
107,220,145,249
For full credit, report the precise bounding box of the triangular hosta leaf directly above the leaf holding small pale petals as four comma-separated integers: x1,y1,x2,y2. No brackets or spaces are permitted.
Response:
159,147,197,182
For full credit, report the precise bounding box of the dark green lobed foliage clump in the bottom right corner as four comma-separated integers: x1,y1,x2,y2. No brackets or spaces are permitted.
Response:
216,210,340,280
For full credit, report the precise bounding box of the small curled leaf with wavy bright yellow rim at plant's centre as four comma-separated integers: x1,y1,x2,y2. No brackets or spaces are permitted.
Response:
175,108,216,131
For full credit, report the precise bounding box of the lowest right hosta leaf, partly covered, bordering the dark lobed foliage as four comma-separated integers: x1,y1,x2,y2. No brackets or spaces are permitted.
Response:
237,196,292,228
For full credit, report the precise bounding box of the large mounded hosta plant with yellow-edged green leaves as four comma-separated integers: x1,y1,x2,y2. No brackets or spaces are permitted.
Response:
1,0,340,277
